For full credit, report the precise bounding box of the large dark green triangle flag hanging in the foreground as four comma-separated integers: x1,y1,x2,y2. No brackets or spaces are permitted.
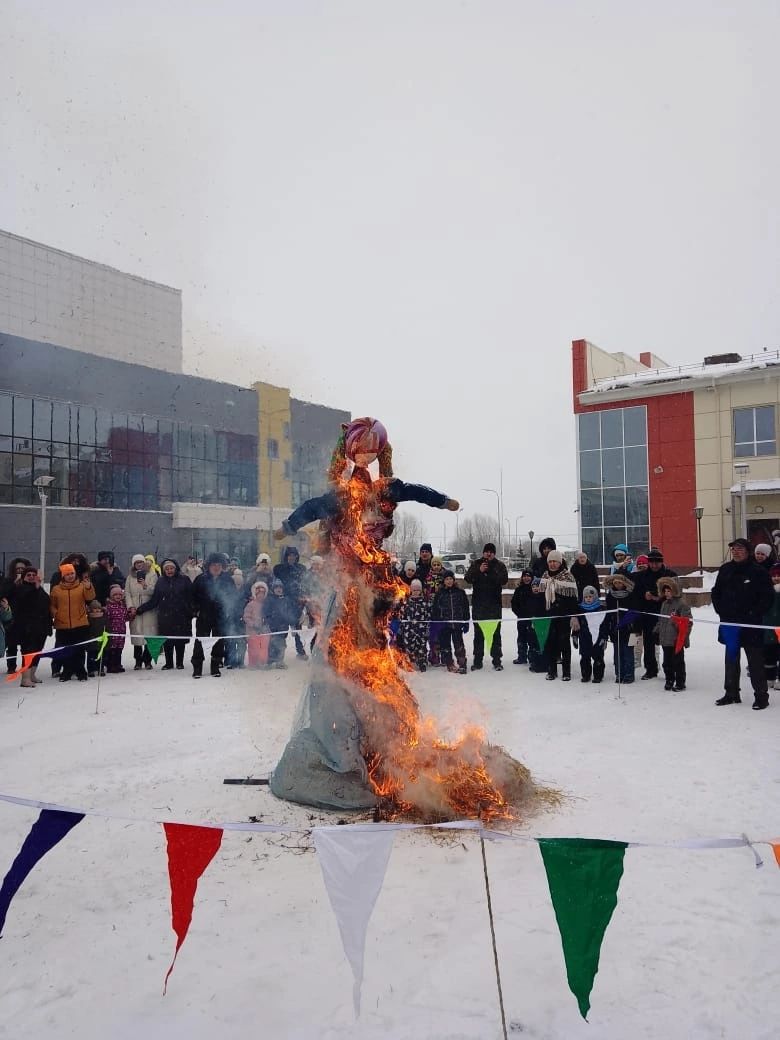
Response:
537,838,626,1019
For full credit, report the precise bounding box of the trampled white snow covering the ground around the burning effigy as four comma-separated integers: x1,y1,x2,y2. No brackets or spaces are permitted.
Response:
0,608,780,1040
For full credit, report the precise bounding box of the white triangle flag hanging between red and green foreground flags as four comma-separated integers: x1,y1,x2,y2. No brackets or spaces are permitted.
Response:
313,826,394,1015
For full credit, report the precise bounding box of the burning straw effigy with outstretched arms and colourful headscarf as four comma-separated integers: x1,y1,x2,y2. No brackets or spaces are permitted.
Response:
269,418,552,821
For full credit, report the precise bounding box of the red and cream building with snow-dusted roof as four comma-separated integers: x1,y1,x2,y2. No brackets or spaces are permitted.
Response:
572,340,780,567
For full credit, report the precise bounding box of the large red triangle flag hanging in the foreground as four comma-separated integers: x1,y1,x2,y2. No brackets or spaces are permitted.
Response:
162,824,223,994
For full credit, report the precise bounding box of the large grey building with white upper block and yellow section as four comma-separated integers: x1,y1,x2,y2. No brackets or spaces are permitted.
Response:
0,232,350,573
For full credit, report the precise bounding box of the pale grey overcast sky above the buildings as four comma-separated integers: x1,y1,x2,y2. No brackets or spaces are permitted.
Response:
0,0,780,542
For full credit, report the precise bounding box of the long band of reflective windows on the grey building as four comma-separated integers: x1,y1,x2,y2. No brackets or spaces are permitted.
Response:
0,392,257,510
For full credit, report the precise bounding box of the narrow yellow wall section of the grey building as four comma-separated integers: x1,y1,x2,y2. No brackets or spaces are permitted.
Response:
254,383,292,555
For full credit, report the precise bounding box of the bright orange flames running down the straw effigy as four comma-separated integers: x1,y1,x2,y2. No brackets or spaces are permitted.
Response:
328,480,531,820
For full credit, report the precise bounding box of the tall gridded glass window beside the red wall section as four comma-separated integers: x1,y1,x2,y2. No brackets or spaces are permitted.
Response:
578,405,650,564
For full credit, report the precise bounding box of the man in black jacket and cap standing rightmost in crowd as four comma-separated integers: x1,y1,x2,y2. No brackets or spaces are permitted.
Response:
712,538,775,710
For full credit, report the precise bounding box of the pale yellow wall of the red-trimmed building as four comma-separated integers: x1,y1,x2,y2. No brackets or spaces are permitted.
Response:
694,375,780,567
